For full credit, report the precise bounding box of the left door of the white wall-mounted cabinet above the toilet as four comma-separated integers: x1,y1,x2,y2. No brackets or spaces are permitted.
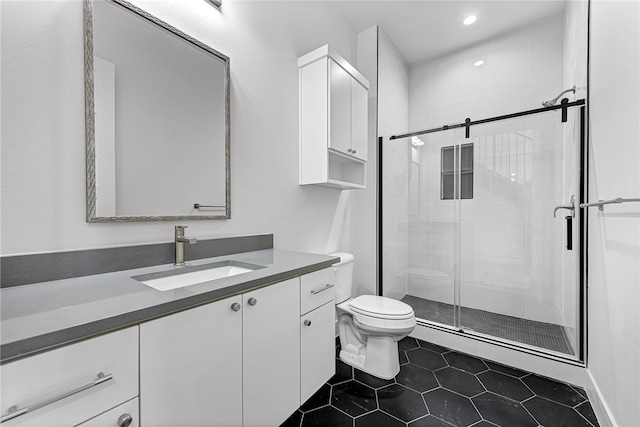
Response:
329,60,352,155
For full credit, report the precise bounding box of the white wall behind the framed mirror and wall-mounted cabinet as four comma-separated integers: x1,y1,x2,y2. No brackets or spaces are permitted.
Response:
0,0,362,255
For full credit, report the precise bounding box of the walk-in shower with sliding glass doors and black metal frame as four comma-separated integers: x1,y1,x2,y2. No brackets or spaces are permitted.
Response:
379,99,586,360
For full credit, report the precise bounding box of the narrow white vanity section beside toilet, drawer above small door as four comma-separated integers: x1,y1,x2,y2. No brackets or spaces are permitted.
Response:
300,267,336,403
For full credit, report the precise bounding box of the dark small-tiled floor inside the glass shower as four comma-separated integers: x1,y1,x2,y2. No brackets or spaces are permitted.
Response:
402,295,575,355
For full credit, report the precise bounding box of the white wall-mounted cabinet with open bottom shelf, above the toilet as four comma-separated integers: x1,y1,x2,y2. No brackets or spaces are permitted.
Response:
298,45,369,189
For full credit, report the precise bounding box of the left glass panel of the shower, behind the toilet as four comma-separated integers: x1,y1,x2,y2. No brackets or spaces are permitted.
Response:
381,129,460,327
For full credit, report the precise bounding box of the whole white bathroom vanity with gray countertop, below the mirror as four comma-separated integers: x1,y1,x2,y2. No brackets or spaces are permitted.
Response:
0,249,337,427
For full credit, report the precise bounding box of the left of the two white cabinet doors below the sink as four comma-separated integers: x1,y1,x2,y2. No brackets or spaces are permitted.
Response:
140,296,242,427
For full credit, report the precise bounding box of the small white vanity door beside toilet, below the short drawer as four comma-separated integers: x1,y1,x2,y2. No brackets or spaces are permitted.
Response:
300,300,336,403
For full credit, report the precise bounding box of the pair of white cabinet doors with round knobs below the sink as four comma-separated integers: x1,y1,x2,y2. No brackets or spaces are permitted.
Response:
140,278,300,427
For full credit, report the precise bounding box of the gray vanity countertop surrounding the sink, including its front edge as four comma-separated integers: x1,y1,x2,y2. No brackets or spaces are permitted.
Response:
0,249,339,363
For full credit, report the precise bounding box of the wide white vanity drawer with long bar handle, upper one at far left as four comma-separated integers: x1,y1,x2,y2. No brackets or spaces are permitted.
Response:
0,326,138,427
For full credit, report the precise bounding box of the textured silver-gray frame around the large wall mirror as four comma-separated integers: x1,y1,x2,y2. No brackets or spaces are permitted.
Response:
83,0,231,223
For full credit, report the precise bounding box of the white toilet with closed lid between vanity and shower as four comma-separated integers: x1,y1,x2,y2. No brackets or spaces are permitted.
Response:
331,252,416,379
